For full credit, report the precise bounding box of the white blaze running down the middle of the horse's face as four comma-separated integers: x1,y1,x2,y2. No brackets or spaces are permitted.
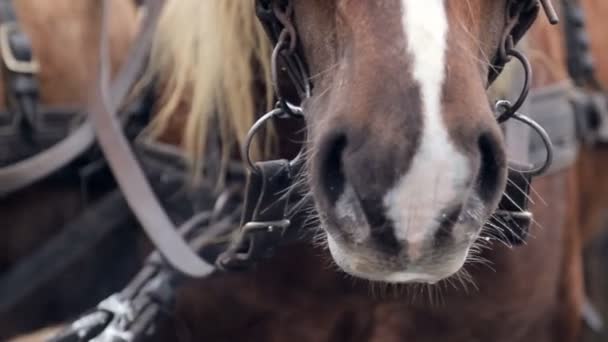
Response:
384,0,470,246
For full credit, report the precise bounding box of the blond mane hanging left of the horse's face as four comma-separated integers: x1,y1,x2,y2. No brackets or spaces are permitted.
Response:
148,0,272,176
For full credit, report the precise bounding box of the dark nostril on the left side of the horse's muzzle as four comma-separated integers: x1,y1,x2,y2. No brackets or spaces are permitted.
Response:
319,133,347,204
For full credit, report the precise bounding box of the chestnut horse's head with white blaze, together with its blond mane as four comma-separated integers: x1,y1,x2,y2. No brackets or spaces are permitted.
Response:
151,0,552,282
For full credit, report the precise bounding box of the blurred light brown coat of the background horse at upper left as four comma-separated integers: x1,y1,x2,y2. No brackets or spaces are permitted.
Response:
0,0,137,106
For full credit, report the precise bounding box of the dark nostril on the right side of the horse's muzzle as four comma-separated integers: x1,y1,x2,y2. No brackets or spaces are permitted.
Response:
477,132,505,201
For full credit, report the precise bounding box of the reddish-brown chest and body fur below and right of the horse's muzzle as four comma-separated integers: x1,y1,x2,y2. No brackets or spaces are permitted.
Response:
140,0,608,342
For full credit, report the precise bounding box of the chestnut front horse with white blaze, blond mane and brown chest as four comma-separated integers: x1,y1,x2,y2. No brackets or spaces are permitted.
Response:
124,0,608,341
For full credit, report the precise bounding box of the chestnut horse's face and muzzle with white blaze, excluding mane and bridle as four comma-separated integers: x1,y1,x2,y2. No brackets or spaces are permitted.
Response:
294,0,540,283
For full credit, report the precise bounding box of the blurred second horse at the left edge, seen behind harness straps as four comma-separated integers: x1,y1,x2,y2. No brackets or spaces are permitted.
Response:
0,0,138,339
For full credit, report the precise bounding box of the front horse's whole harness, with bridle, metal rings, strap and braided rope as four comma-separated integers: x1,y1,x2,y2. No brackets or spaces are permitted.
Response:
29,0,608,342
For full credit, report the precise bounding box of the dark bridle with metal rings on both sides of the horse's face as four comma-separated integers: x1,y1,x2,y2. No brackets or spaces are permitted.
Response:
251,0,558,244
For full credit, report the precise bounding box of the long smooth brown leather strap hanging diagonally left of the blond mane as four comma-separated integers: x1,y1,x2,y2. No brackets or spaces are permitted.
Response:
90,0,214,277
